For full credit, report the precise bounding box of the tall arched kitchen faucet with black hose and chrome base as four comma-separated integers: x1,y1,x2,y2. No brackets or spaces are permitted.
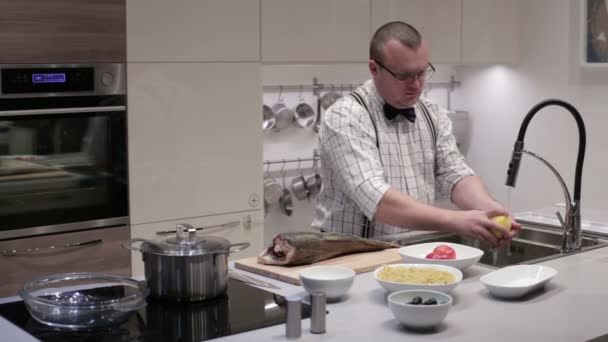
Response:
506,100,587,253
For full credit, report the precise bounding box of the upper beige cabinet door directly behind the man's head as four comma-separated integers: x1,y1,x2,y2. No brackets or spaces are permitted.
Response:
372,0,462,64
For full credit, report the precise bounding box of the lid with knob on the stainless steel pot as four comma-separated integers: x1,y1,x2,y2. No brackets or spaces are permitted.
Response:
141,223,230,256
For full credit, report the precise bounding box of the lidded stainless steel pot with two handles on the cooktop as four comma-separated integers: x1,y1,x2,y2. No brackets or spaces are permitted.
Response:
123,224,249,302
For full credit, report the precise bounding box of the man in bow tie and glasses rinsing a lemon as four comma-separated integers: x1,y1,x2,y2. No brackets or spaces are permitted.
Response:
312,22,521,246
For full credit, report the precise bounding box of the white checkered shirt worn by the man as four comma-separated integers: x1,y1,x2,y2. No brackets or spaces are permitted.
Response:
312,80,474,236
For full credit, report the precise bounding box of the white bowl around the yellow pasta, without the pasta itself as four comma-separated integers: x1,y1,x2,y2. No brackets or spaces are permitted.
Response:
374,264,462,293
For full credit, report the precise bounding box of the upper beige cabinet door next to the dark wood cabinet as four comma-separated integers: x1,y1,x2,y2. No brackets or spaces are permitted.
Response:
127,0,260,62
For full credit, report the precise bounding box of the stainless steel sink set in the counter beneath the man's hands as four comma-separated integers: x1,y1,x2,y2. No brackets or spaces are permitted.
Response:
396,225,608,268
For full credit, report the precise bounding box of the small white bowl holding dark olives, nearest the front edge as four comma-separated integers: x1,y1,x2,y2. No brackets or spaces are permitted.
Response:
388,290,452,329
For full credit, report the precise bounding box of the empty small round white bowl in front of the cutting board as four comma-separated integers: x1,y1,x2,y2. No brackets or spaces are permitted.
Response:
299,266,355,299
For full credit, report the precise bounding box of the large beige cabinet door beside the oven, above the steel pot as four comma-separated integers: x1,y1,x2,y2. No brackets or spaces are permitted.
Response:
127,63,263,224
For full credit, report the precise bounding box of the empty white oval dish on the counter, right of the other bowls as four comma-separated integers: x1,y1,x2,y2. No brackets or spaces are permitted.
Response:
479,265,557,298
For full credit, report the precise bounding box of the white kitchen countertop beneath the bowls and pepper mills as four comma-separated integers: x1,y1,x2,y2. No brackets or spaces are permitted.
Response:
0,243,608,342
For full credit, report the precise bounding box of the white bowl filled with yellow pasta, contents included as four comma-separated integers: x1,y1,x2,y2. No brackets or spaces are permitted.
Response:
374,264,462,293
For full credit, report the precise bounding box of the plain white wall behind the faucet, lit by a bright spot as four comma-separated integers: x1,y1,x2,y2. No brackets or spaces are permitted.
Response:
455,0,608,215
